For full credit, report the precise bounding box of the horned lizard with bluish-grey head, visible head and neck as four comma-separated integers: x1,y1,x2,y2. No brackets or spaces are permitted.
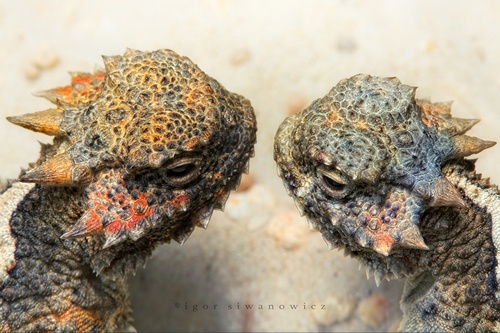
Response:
274,75,500,332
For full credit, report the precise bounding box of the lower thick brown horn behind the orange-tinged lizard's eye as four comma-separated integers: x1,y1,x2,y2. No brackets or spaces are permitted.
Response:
19,154,92,186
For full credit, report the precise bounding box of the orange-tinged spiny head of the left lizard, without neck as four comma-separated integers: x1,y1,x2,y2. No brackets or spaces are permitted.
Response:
8,50,256,248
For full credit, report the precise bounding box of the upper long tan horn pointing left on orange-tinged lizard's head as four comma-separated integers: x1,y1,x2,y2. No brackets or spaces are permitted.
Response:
7,109,64,136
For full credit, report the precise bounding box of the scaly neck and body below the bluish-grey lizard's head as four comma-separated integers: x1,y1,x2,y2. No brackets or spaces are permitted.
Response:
401,161,500,331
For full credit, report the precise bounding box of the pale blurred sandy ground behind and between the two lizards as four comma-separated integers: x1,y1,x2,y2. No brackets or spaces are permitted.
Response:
0,0,500,332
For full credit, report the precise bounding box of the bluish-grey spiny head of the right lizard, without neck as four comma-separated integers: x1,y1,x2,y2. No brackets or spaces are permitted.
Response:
274,75,494,276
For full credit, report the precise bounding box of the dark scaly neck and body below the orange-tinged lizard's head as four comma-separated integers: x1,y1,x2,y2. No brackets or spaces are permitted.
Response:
0,183,131,331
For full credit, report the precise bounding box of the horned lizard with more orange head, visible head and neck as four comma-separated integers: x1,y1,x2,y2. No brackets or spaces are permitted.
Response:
0,50,256,331
